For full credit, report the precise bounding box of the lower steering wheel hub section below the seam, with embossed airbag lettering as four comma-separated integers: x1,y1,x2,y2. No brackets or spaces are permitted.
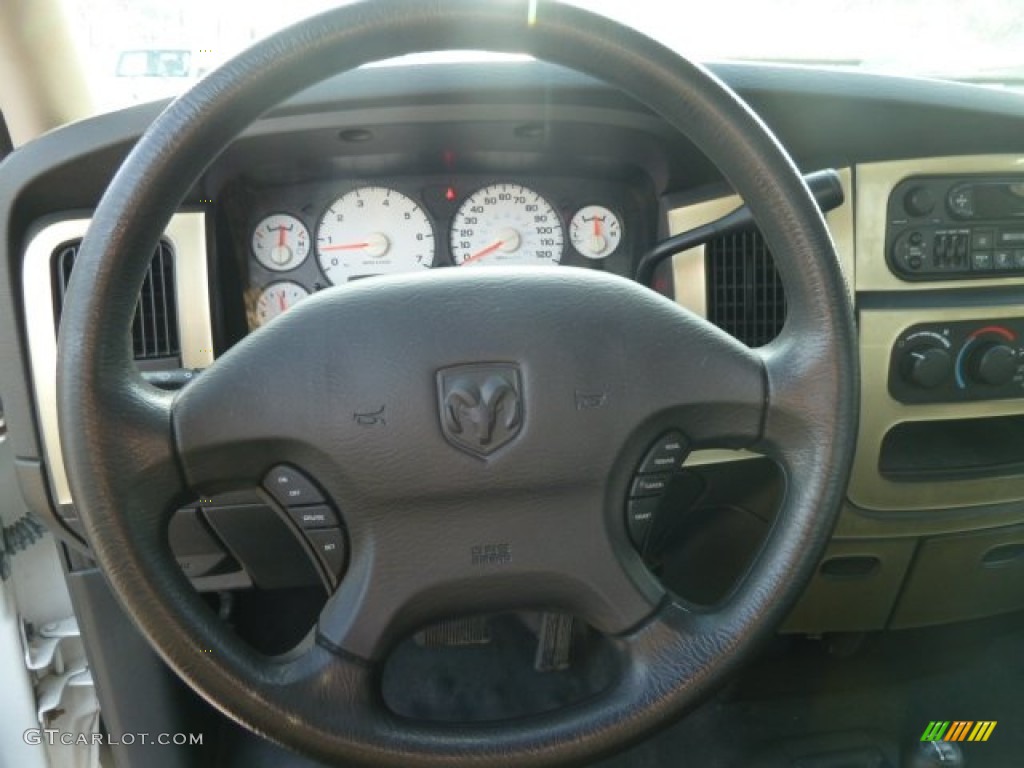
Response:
317,484,665,659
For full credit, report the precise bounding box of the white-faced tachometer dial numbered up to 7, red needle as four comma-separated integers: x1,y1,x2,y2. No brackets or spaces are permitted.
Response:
316,186,434,285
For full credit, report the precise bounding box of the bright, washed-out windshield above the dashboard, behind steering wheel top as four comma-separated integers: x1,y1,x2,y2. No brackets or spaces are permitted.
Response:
63,0,1024,111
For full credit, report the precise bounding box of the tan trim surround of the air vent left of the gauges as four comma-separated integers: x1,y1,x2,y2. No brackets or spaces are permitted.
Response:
22,213,213,505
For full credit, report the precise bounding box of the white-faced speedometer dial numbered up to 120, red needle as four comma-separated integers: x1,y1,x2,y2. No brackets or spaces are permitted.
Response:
452,184,564,266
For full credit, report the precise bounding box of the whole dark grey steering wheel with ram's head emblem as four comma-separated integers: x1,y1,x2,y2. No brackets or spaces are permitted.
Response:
57,0,858,768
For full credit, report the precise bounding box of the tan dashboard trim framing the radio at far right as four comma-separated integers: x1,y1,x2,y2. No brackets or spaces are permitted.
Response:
856,155,1024,291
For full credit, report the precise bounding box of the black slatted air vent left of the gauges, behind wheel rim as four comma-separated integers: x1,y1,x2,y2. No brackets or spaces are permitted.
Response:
52,240,181,360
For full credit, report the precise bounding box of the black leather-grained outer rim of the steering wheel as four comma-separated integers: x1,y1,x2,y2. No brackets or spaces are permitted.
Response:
58,0,858,766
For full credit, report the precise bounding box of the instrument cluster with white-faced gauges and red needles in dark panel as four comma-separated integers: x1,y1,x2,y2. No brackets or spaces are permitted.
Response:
244,177,650,328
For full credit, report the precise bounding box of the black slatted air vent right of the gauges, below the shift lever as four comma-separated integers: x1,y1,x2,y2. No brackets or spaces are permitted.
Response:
705,230,785,347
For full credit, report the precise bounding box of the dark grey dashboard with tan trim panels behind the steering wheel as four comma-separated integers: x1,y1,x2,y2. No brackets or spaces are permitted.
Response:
0,62,1024,633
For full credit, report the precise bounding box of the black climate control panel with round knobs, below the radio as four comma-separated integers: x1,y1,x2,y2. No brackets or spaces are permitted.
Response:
889,318,1024,403
